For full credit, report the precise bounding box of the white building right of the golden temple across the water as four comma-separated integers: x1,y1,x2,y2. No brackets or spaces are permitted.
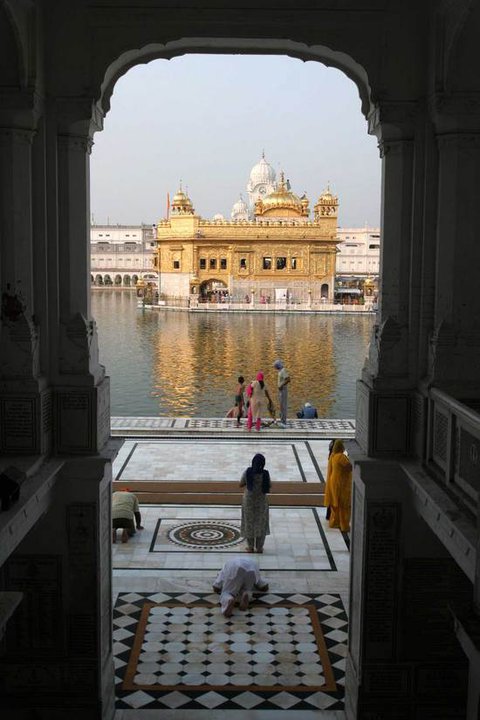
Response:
335,226,380,300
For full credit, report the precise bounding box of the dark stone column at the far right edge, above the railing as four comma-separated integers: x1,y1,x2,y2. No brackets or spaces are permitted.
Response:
428,122,480,401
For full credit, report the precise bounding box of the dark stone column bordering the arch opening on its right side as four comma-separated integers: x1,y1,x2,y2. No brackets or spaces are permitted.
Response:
357,107,415,456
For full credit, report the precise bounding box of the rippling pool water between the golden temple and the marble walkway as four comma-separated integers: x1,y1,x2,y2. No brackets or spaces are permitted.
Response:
92,290,374,418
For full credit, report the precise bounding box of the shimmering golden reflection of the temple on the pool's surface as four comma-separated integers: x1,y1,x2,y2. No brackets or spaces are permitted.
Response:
153,313,340,417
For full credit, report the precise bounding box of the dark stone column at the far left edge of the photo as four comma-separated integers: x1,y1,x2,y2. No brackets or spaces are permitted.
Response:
0,122,51,455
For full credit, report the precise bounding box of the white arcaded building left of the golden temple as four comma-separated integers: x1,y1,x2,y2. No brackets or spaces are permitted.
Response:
90,225,158,287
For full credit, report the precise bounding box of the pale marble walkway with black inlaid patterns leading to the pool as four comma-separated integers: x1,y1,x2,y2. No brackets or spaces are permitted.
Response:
112,421,352,720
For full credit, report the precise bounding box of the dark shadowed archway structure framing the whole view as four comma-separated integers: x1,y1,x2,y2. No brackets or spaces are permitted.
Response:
0,0,480,720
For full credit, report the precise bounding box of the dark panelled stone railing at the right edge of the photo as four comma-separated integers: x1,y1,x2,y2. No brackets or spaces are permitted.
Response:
427,388,480,513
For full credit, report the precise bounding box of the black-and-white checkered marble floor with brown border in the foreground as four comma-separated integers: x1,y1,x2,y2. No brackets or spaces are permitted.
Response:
113,593,348,710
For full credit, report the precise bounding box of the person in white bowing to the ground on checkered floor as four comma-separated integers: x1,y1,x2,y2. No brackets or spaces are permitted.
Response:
213,557,268,617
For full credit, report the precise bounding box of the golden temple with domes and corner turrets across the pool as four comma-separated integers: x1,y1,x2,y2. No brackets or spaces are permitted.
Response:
157,157,338,302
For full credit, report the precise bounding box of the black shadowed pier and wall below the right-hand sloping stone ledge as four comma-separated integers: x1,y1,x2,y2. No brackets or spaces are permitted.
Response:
345,458,472,720
